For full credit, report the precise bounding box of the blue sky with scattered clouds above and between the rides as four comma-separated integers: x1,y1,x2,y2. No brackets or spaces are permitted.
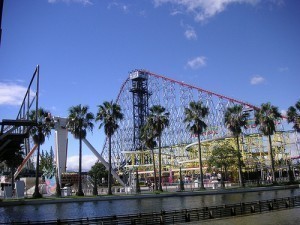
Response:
0,0,300,169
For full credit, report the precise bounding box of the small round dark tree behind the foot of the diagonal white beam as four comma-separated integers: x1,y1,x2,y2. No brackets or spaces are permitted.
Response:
88,162,108,195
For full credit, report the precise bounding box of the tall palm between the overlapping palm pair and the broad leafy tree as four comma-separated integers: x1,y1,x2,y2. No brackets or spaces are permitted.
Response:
183,101,209,189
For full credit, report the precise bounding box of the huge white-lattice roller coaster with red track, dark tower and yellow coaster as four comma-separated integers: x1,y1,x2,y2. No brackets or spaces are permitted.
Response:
101,70,299,182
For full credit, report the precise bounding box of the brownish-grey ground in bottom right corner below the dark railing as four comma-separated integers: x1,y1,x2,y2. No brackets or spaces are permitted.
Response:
178,208,300,225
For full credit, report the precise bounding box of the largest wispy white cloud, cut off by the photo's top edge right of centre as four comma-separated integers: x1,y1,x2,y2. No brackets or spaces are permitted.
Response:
154,0,261,22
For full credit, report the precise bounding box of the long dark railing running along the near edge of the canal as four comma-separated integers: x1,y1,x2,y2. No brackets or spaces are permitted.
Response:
4,196,300,225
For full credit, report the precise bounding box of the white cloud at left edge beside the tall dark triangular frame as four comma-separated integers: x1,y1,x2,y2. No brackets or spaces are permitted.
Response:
0,82,27,105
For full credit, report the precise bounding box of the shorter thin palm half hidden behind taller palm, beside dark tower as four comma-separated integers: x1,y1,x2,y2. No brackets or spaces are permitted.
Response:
141,123,158,191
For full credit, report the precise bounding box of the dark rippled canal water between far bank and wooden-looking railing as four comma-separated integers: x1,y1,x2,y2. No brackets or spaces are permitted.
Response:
0,189,300,223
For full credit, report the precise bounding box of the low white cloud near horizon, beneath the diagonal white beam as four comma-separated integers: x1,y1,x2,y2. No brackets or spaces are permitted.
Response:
67,155,98,171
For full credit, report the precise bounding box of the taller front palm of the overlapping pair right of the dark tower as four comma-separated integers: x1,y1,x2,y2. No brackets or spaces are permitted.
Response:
147,105,170,191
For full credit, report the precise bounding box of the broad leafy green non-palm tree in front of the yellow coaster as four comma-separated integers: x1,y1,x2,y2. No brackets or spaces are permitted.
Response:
207,143,239,188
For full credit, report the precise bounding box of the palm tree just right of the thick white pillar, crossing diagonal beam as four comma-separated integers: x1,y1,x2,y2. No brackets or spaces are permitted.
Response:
67,104,94,196
